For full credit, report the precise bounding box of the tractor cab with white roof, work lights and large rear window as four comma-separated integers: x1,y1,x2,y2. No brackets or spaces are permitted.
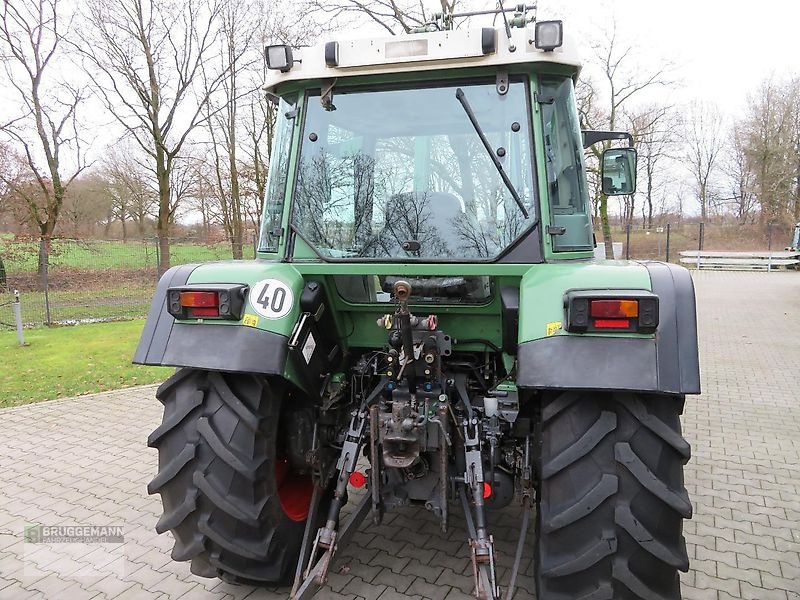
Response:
259,17,593,272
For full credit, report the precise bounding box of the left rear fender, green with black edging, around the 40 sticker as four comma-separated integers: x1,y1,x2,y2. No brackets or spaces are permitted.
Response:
133,261,303,375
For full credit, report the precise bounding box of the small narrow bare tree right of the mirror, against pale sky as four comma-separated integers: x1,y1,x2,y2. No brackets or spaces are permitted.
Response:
685,102,725,221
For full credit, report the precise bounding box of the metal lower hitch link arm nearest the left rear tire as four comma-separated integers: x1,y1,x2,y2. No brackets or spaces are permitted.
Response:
289,410,371,600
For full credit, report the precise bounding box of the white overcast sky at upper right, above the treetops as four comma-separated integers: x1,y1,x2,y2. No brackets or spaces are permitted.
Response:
538,0,800,116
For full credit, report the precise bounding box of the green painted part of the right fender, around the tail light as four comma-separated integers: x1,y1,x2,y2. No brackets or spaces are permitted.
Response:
519,260,651,343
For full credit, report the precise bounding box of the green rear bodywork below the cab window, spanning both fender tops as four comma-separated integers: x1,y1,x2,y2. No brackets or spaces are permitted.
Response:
178,253,651,349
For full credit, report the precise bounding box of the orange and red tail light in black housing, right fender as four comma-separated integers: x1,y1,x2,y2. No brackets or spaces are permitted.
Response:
564,290,658,333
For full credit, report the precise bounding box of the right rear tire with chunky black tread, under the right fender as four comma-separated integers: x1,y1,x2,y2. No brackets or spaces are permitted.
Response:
535,391,692,600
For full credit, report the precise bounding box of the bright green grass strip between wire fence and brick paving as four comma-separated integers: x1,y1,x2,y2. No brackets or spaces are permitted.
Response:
0,321,173,407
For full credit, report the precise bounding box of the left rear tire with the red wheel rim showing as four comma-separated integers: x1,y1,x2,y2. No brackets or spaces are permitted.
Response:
147,369,326,584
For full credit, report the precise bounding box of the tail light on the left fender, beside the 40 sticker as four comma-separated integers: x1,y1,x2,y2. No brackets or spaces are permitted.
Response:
167,284,247,321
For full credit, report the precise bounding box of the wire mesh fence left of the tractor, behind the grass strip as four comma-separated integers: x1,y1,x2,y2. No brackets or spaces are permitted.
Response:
0,238,254,328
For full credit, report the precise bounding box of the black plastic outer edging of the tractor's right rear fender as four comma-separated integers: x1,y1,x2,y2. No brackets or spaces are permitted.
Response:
517,262,700,394
